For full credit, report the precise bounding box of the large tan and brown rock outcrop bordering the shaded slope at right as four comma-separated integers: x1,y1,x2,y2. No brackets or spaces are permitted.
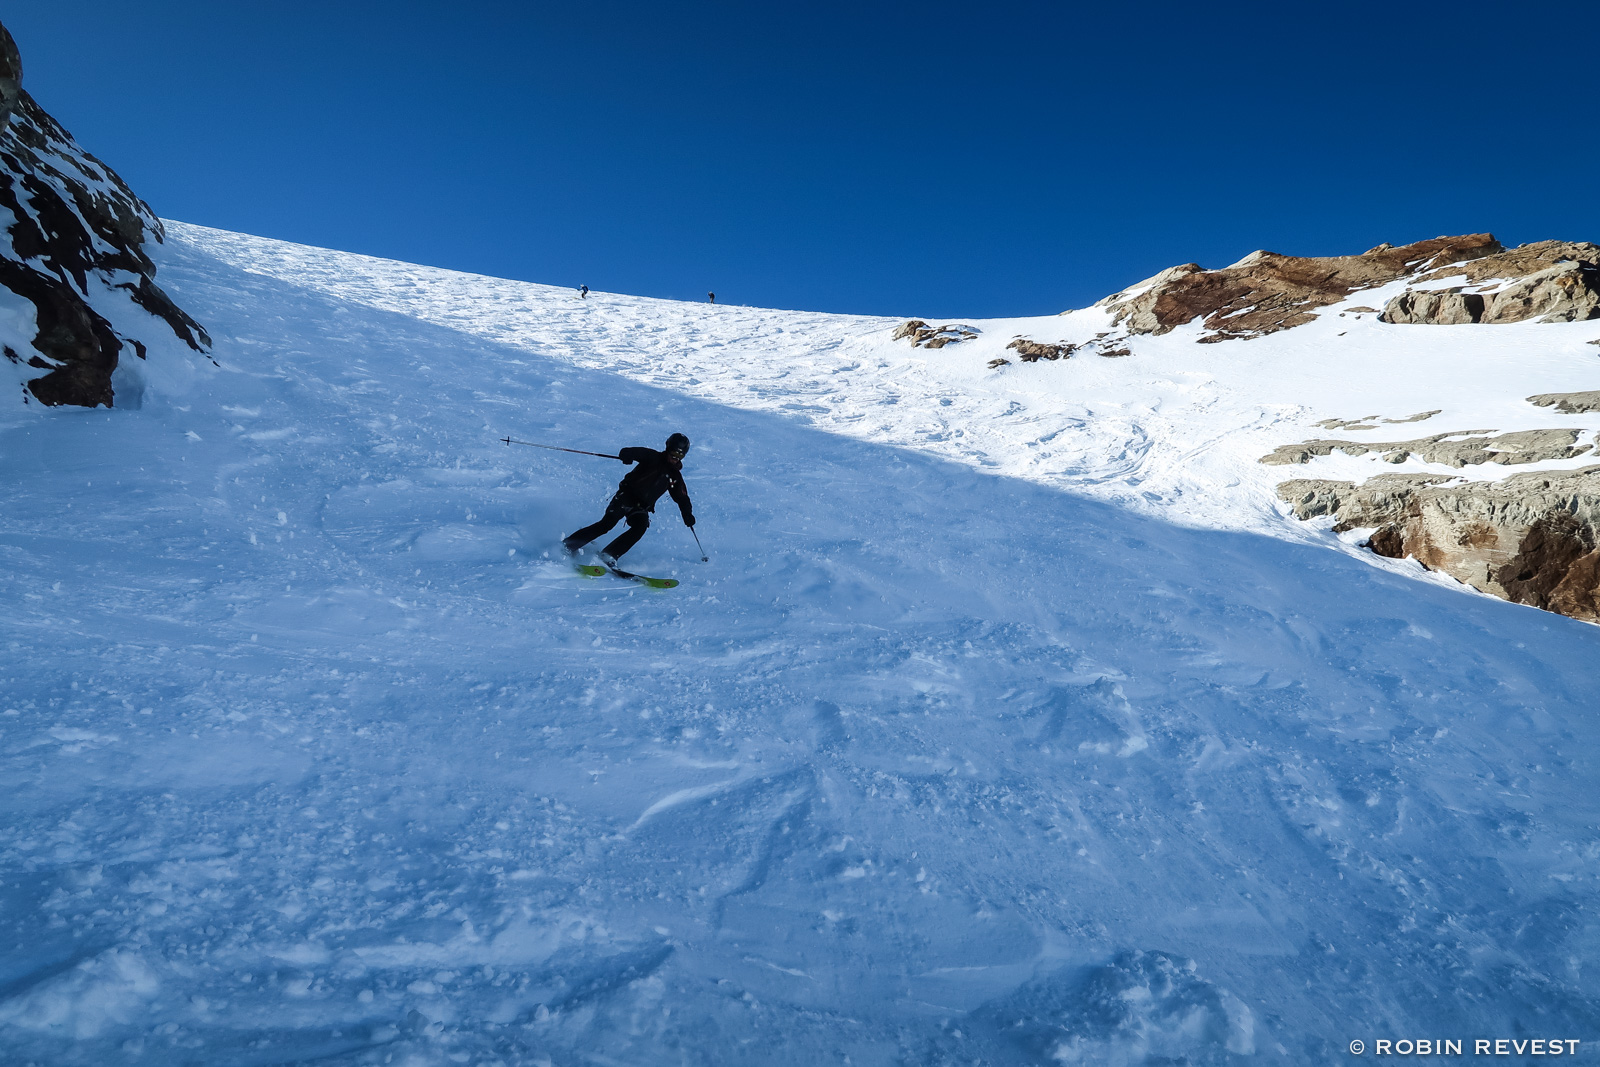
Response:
1278,467,1600,622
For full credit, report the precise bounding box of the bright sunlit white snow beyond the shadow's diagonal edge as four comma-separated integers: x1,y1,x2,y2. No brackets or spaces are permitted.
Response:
168,224,1600,543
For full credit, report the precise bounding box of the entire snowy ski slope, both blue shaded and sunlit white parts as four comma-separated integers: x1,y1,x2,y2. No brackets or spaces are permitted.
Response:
9,224,1600,1067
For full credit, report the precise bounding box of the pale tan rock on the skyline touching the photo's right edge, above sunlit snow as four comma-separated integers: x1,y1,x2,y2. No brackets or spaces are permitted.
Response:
1379,242,1600,326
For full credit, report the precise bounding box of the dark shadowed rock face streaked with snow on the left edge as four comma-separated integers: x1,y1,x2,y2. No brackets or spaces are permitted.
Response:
0,17,211,408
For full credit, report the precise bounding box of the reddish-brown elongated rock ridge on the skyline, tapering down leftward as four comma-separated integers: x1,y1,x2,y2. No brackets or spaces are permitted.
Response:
1096,234,1502,341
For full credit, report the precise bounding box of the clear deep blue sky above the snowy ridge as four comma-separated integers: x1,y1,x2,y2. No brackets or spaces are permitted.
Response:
0,0,1600,317
